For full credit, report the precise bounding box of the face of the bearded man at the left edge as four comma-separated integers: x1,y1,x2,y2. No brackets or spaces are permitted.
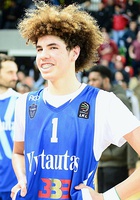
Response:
0,61,18,89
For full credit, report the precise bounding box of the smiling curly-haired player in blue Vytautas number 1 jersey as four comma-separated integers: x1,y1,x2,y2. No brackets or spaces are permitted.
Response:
11,1,140,200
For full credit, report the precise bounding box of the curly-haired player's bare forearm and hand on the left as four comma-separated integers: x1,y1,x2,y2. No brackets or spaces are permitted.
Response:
11,142,27,198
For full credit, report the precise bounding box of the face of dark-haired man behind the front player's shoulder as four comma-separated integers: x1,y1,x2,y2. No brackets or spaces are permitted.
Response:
88,72,104,89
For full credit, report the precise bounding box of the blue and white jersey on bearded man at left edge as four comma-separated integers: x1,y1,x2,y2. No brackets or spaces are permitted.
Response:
0,96,17,192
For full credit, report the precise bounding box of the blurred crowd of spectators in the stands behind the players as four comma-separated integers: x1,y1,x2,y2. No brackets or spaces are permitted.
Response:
0,0,140,115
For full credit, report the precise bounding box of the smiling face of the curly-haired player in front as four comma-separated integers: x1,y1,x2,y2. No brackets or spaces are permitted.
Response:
36,35,78,82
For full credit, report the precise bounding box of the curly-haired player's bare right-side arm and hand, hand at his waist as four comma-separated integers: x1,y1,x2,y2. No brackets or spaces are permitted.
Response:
75,127,140,200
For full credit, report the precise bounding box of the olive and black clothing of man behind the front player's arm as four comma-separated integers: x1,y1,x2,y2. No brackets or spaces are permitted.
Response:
97,85,138,193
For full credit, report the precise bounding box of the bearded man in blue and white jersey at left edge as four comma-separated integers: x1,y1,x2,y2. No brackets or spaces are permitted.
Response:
0,54,19,200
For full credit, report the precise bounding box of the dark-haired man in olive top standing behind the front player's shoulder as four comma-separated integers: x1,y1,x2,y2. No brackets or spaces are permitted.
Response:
88,65,138,193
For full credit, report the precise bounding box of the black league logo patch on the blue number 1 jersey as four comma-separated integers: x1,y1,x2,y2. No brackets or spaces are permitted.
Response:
78,102,90,119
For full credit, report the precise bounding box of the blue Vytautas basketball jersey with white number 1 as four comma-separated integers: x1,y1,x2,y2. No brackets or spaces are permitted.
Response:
16,86,99,200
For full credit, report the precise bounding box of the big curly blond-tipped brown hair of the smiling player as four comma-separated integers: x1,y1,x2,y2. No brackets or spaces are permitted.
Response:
18,1,103,72
